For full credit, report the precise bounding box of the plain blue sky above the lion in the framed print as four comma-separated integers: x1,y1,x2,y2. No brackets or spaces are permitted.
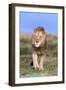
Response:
19,12,58,36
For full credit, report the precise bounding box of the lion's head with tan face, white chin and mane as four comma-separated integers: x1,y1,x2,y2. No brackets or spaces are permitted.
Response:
32,27,46,48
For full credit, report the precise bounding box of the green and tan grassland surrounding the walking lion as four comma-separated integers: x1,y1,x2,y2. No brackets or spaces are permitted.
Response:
20,33,58,77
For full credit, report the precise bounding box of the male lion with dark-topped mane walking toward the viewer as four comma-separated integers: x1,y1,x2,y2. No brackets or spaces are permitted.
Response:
32,27,46,70
